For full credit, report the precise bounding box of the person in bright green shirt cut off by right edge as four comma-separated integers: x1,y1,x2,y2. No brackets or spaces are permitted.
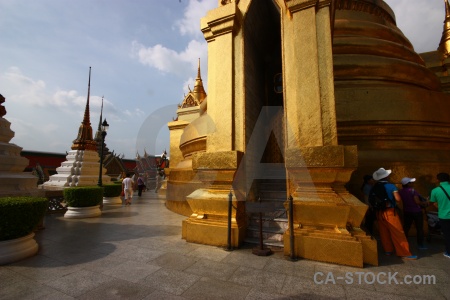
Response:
430,173,450,258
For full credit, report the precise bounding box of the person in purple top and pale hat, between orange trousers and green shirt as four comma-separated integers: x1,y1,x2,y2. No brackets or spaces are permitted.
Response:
399,177,427,250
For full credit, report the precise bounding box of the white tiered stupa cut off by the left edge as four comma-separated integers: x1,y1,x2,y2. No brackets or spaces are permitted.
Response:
0,95,38,197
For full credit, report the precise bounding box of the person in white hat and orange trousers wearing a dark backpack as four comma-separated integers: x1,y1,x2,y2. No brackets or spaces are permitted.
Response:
369,168,417,260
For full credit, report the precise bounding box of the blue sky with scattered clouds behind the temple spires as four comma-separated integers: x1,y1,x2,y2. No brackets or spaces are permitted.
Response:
0,0,445,159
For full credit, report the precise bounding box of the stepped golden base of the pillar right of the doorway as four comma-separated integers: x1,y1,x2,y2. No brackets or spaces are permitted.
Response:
284,145,378,268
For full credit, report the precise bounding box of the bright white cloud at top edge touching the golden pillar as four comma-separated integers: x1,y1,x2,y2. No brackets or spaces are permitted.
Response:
175,0,217,37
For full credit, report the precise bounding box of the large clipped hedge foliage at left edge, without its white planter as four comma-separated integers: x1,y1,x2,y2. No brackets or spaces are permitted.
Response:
0,196,48,241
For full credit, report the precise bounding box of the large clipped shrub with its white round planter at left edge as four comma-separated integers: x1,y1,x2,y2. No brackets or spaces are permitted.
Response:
0,196,48,265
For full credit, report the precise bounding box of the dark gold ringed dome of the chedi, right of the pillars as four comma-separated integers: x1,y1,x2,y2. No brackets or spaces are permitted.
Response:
333,1,450,199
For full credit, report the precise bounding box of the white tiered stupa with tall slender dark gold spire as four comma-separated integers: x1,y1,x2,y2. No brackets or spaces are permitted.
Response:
40,68,111,190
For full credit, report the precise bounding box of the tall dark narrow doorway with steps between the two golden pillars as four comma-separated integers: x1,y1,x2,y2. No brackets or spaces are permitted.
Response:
243,0,287,247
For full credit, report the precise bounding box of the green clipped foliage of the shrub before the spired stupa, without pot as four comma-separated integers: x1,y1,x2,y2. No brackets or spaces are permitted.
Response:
64,186,103,207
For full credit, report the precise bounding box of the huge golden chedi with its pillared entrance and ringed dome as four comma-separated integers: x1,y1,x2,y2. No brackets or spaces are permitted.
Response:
167,0,450,267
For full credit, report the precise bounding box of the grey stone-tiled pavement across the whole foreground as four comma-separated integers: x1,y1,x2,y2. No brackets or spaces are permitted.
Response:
0,191,450,300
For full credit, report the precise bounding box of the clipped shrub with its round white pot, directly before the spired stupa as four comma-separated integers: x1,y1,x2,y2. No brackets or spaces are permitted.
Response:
64,186,103,218
